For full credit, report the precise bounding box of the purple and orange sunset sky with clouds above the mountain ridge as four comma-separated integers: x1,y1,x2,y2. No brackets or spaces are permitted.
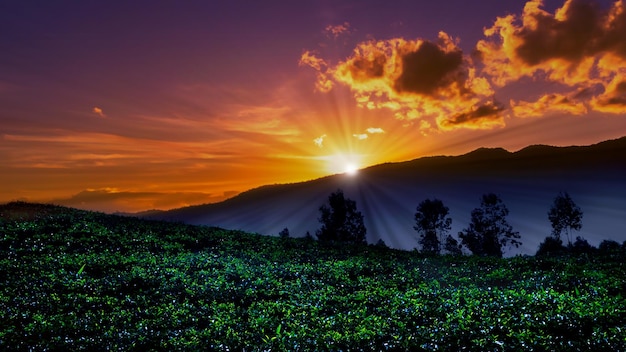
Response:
0,0,626,212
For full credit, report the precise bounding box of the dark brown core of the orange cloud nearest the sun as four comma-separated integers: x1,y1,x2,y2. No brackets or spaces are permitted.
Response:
394,41,467,95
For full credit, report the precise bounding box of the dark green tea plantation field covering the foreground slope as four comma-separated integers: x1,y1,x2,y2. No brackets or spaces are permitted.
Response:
0,203,626,351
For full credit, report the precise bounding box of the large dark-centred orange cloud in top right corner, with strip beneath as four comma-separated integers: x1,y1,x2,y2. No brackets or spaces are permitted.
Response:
476,0,626,110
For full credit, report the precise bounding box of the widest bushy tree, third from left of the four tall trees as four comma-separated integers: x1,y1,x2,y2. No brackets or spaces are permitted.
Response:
459,193,522,257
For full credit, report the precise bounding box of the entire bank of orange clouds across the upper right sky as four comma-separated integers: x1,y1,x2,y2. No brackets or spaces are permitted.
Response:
300,0,626,133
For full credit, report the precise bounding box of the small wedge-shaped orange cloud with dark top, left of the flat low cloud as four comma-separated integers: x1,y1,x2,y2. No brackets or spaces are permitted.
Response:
437,101,504,130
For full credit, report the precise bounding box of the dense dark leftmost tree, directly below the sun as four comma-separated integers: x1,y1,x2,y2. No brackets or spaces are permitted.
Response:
316,189,367,243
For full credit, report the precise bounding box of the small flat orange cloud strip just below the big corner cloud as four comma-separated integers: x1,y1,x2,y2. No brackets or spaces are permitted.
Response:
511,93,587,118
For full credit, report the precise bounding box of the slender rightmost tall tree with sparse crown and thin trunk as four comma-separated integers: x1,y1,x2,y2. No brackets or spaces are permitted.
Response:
548,192,583,245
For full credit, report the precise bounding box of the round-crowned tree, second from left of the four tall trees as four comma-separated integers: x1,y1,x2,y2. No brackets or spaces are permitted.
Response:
413,199,452,254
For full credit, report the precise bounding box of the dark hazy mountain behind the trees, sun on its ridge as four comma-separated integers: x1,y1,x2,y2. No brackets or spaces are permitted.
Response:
149,137,626,255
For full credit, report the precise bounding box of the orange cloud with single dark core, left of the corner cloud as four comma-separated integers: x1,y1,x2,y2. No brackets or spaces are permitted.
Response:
310,32,493,128
